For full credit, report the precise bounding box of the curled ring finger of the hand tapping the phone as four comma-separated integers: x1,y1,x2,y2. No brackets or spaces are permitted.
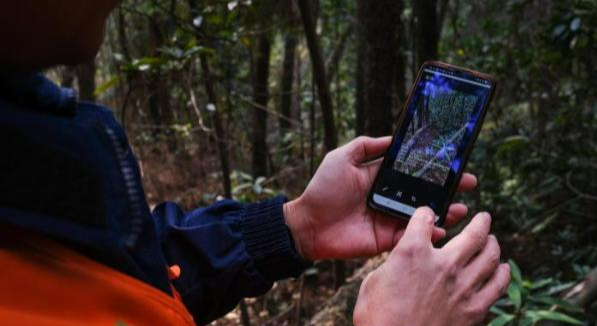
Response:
463,235,501,290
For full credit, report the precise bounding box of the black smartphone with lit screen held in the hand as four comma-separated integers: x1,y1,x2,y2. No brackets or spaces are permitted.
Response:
367,61,496,225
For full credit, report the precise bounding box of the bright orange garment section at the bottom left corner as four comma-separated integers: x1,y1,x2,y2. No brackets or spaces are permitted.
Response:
0,229,195,326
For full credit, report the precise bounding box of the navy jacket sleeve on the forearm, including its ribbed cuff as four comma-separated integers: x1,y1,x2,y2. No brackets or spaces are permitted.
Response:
153,197,308,325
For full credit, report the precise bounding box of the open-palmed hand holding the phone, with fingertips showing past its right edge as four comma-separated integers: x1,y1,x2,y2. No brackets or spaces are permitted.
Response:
284,137,477,260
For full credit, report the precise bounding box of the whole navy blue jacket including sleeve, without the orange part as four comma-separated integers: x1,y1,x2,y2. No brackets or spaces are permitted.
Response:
0,74,306,324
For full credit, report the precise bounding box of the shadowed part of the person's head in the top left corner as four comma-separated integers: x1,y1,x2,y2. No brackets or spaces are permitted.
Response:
0,0,118,71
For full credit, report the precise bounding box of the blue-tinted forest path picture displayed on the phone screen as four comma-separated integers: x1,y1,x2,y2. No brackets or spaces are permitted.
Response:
392,74,479,186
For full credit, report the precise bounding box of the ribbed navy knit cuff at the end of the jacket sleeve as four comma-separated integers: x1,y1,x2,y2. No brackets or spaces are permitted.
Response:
241,196,311,282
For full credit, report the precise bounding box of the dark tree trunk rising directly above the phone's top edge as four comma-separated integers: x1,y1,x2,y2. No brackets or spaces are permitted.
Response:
412,0,440,66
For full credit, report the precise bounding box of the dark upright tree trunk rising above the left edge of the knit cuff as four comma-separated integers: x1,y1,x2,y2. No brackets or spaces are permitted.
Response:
251,32,271,178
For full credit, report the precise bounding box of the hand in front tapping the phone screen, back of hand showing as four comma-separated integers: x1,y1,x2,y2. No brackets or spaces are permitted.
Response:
353,208,510,326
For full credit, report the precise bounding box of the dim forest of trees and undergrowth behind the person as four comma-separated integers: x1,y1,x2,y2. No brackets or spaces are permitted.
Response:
47,0,597,326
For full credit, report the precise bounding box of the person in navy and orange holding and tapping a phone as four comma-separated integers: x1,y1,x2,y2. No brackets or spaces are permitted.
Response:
0,0,509,326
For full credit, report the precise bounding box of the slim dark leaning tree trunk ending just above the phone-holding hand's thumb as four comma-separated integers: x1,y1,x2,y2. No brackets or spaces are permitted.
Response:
296,0,338,152
